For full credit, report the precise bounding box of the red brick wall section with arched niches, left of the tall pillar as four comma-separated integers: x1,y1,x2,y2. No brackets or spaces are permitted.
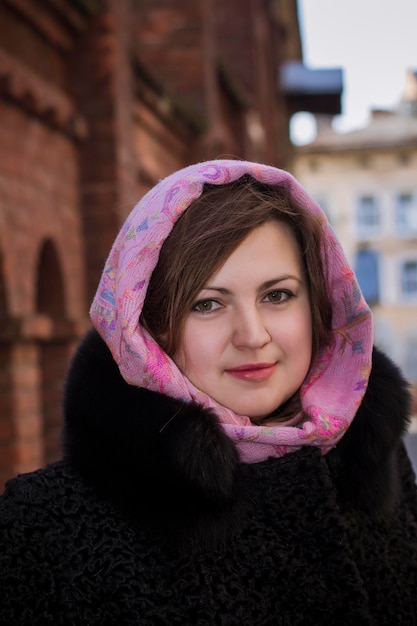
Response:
0,3,86,488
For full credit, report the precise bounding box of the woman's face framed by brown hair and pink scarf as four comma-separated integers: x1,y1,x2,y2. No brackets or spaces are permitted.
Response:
174,222,312,420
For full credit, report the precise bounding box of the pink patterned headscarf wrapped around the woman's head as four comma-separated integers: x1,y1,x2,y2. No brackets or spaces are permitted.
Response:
90,160,372,463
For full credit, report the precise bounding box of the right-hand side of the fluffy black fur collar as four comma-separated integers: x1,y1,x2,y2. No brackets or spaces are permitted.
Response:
328,348,411,514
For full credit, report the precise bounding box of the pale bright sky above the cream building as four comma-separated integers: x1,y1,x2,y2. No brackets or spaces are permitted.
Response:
292,0,417,143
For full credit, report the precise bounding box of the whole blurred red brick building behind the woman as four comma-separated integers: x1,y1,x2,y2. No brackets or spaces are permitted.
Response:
0,0,341,489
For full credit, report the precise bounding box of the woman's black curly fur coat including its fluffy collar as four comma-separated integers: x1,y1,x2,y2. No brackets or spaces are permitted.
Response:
0,331,417,626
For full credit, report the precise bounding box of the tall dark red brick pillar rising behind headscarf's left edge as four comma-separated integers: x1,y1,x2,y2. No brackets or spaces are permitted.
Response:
69,1,138,301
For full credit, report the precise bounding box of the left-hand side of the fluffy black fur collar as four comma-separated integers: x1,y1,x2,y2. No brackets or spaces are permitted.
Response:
64,330,241,532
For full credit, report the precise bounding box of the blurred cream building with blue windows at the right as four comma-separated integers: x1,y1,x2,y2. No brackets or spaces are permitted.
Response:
292,71,417,409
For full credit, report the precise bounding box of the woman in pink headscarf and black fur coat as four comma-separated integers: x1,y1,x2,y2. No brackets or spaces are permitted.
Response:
0,160,417,626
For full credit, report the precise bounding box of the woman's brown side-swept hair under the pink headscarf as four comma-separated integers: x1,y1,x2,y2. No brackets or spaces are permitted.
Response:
141,175,330,358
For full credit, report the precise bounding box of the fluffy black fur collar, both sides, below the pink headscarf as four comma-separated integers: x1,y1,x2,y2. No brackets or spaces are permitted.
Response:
64,330,410,519
